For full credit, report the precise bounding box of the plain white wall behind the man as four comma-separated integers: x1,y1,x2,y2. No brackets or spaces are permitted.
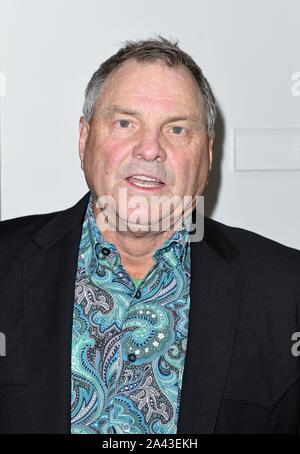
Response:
0,0,300,249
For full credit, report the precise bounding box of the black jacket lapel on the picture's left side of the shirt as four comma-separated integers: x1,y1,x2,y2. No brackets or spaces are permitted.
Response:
24,193,90,433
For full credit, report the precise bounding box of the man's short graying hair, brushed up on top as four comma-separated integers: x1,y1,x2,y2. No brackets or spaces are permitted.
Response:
83,36,217,138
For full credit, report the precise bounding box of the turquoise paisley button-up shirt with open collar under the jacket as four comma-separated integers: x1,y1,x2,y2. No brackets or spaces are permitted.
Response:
71,196,190,434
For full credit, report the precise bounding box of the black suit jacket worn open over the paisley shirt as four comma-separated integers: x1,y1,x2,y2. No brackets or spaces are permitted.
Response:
0,192,300,434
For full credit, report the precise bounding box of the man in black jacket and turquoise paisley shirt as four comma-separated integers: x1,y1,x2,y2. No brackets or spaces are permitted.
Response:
0,38,300,434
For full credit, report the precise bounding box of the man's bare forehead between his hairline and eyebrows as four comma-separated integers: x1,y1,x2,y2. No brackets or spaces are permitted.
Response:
97,61,203,120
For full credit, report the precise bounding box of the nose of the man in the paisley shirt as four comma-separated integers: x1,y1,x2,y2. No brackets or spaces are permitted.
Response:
133,132,166,162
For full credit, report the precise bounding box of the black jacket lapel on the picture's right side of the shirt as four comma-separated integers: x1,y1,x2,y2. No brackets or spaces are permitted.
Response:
178,218,242,434
